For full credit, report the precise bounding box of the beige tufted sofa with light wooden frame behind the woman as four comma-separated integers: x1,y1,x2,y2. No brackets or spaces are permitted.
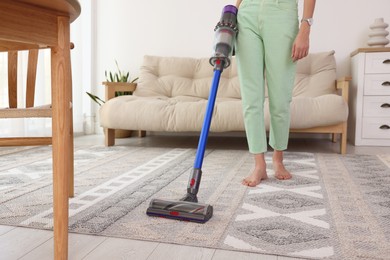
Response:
100,51,349,153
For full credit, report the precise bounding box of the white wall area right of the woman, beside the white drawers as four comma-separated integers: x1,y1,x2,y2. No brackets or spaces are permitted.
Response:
310,0,390,76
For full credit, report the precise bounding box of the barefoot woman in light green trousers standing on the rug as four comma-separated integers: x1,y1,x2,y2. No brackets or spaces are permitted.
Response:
236,0,316,187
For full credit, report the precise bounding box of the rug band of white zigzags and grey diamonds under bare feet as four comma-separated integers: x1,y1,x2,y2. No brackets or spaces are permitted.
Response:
224,153,336,258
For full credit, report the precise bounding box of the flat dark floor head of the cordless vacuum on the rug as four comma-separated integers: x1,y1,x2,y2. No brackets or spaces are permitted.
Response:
146,199,213,223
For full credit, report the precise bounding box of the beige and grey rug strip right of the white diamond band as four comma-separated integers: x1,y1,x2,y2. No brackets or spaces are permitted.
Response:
319,154,390,259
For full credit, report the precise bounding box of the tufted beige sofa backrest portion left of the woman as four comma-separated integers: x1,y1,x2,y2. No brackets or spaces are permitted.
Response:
134,56,241,99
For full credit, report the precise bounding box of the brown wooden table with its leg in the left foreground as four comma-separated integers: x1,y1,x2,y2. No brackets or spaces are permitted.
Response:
0,0,81,259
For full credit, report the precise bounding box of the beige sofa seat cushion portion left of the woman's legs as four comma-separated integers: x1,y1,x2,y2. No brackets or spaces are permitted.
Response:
100,96,244,132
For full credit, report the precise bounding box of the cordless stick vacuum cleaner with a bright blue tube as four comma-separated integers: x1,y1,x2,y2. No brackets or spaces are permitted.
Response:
146,5,238,223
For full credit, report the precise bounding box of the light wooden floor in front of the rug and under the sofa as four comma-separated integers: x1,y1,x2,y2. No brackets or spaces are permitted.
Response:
0,135,390,260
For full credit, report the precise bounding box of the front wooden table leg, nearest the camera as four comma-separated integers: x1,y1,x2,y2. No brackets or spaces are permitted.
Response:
51,17,73,260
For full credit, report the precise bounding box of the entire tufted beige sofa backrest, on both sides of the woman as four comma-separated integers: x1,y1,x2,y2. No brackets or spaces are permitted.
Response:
134,51,336,99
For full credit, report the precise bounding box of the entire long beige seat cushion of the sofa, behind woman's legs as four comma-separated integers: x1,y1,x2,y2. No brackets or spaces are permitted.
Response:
100,94,348,132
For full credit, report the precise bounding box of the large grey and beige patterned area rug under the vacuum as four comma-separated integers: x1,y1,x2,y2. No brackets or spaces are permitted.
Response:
0,146,390,259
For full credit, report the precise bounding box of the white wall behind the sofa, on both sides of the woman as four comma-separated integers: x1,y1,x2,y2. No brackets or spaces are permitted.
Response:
94,0,390,132
